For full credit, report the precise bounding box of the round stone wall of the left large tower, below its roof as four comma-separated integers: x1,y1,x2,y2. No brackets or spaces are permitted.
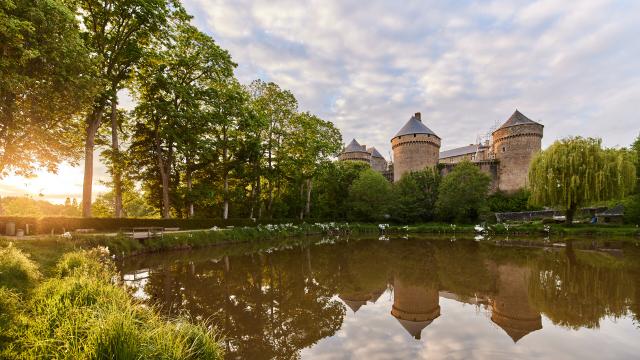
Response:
391,134,440,181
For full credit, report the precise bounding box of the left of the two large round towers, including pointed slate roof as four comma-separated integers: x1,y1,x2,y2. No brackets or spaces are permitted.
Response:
391,112,440,182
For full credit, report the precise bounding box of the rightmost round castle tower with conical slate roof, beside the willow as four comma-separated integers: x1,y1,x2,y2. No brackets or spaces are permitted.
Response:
491,110,544,191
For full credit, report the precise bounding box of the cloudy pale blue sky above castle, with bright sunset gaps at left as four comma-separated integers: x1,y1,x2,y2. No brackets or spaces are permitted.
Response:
0,0,640,199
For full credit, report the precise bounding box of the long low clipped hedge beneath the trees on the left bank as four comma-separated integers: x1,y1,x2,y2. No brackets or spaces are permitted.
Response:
0,216,299,234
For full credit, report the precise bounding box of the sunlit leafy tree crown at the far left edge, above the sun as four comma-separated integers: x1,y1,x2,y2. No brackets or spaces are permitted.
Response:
0,0,93,177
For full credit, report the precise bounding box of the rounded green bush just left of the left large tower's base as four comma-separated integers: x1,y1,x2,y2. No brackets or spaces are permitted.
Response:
349,169,391,221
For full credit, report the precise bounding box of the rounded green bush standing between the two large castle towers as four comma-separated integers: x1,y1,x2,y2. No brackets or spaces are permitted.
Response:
436,161,491,223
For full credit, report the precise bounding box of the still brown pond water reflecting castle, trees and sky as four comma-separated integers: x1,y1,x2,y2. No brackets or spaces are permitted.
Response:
120,238,640,359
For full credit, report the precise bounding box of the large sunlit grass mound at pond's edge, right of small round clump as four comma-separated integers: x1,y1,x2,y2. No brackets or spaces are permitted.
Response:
13,250,222,359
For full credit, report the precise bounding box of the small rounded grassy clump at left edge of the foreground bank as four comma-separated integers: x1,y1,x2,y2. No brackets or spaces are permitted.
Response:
0,244,40,292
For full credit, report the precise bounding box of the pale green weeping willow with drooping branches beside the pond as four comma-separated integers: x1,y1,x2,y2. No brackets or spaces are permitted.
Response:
529,137,636,224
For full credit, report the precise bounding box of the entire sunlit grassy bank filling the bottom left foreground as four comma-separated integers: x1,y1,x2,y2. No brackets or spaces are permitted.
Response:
0,245,222,359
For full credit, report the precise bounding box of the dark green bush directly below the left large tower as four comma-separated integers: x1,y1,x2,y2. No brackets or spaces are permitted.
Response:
391,168,441,224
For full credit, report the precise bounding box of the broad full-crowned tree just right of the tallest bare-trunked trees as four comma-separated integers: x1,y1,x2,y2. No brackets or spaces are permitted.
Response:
131,22,236,218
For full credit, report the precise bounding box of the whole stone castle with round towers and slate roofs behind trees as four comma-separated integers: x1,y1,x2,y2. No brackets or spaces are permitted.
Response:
338,110,544,192
